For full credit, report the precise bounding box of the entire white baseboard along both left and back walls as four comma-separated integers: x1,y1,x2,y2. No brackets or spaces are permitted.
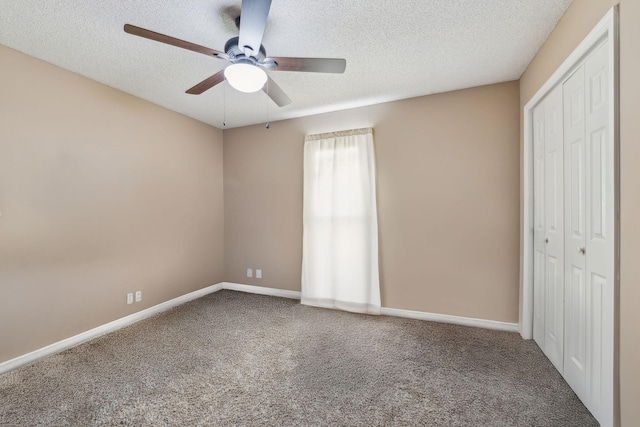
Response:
0,282,518,374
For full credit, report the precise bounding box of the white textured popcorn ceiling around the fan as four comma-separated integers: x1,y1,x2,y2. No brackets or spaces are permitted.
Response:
0,0,571,127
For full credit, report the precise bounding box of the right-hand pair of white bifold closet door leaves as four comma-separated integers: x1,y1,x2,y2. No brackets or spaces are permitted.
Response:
563,44,615,425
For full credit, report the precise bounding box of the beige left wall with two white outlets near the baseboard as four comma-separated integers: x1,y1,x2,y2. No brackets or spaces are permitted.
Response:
0,46,224,362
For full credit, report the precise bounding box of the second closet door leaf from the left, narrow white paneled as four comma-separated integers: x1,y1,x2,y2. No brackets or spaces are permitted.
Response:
543,86,564,373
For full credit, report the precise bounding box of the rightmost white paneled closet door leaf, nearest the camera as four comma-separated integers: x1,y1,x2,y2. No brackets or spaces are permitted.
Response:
584,44,615,425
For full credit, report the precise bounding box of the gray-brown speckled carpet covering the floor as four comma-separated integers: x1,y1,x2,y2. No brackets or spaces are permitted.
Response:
0,291,597,427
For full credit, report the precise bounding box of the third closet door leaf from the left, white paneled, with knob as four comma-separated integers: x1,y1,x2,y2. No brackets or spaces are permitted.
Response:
563,66,587,402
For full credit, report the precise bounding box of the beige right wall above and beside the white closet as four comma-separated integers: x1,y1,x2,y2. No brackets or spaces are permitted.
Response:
520,0,640,426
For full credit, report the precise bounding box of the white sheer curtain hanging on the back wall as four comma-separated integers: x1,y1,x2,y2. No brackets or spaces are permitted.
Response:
302,129,380,314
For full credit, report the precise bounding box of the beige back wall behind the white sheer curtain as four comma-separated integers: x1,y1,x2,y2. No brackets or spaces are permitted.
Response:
224,82,519,322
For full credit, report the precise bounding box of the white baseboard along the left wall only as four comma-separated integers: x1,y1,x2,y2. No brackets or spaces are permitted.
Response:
0,283,222,374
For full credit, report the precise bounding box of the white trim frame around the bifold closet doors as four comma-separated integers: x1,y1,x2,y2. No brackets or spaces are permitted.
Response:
518,5,620,418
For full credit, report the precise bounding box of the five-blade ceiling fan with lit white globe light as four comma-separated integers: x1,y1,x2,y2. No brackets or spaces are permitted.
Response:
124,0,347,107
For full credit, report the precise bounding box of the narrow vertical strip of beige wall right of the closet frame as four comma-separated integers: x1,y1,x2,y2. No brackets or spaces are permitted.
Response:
620,0,640,426
